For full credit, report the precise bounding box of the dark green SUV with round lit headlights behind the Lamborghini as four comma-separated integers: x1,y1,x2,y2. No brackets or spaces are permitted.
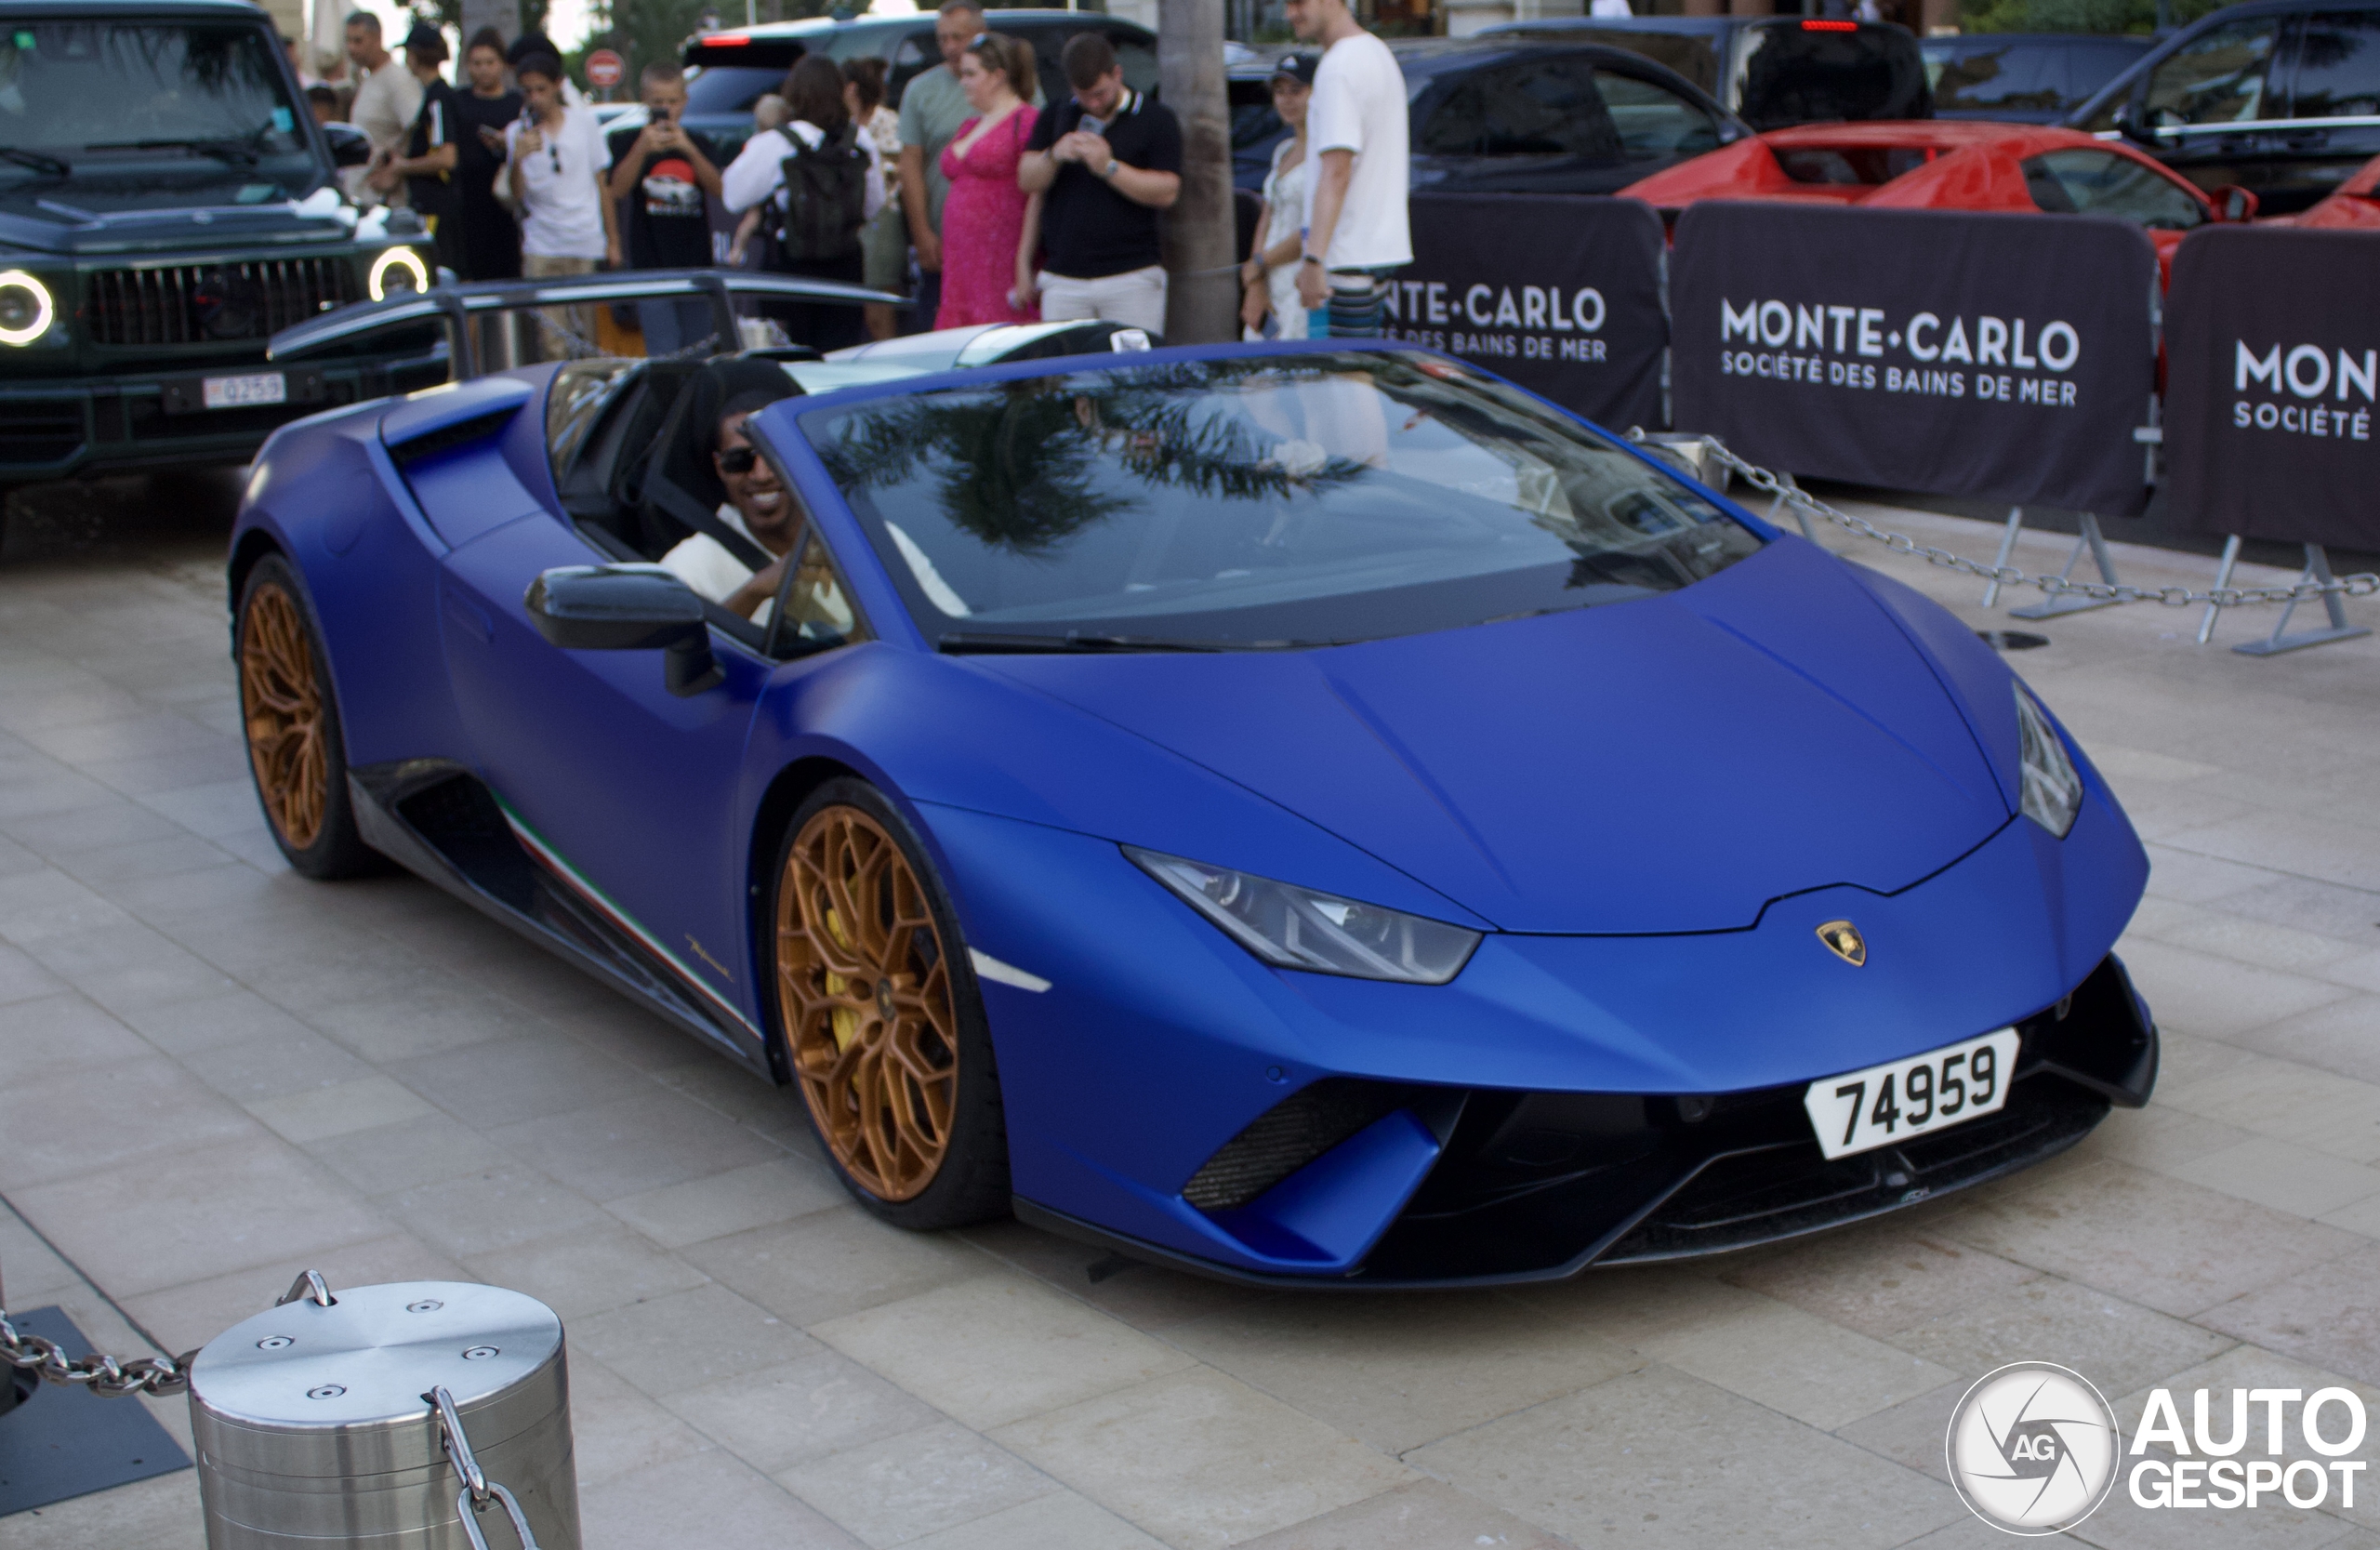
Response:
0,0,447,488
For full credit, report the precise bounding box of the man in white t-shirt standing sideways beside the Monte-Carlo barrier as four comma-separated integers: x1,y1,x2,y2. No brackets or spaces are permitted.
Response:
1288,0,1414,338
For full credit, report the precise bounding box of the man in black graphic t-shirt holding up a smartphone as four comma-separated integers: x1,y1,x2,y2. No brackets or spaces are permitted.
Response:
609,60,719,355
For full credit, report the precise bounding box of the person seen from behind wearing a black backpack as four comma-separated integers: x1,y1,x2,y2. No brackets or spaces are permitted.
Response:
721,55,885,350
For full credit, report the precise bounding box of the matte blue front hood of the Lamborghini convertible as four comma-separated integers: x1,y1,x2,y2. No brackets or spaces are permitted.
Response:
978,540,2011,934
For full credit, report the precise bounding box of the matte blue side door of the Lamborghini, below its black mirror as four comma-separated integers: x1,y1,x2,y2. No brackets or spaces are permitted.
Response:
441,485,771,1065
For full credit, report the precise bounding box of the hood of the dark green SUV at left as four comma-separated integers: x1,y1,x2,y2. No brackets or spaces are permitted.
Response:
0,174,354,255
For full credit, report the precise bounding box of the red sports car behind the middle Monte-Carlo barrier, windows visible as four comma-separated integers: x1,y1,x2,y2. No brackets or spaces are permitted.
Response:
1620,119,2256,279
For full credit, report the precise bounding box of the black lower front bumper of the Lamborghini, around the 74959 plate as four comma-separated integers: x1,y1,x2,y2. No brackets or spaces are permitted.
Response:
1016,955,2159,1291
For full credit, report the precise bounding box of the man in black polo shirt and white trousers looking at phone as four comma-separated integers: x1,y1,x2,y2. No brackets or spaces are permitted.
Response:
1016,33,1183,333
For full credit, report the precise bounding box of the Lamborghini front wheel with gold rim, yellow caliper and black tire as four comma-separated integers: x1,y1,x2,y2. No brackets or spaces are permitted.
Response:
764,776,1009,1231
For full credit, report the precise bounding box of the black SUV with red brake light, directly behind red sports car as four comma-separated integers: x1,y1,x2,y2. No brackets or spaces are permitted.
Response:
1480,17,1933,128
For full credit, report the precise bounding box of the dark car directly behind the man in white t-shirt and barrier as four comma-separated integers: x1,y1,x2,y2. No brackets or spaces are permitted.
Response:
1231,35,1747,192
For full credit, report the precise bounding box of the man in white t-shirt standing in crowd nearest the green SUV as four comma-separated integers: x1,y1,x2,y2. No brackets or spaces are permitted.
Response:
505,55,621,357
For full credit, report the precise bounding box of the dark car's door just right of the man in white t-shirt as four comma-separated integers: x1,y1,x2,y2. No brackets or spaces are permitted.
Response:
1414,55,1635,192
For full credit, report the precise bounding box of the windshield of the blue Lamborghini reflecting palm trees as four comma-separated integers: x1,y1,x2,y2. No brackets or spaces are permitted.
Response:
802,352,1759,650
